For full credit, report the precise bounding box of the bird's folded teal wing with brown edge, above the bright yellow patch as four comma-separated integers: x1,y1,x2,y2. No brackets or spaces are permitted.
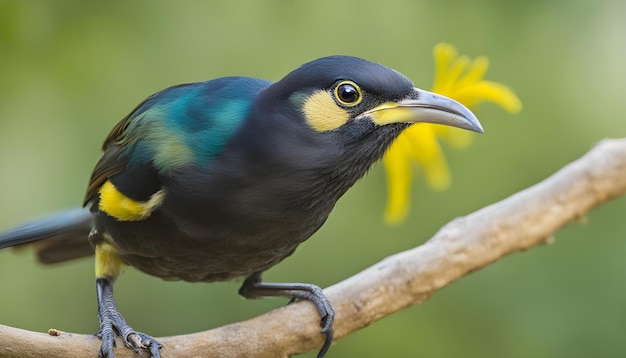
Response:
84,77,271,204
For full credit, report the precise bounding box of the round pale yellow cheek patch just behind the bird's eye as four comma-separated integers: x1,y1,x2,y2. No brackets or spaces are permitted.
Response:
303,91,350,132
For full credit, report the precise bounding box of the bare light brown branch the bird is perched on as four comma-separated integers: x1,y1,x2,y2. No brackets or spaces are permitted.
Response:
0,138,626,358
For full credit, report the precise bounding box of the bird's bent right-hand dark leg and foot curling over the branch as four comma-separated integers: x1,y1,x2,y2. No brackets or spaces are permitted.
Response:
239,272,335,358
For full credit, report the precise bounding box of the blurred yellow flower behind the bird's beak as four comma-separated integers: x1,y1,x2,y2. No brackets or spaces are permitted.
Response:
383,43,522,224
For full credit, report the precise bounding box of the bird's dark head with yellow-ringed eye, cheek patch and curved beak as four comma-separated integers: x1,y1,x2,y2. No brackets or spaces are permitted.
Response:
251,56,483,142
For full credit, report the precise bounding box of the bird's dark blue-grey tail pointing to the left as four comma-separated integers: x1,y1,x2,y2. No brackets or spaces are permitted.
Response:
0,208,94,264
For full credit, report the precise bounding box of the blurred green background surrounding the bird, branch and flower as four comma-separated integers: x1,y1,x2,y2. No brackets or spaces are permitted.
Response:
0,0,626,357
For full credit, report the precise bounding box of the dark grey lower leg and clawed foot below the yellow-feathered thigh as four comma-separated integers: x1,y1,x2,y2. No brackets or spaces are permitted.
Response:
96,278,163,358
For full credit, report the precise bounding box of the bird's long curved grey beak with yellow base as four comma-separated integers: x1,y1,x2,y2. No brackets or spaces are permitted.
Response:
362,88,483,133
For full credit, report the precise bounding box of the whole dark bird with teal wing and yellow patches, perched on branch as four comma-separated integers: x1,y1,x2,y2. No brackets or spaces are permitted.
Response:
0,55,483,358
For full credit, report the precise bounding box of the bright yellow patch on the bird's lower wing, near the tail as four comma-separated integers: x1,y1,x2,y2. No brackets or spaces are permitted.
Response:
98,180,165,221
